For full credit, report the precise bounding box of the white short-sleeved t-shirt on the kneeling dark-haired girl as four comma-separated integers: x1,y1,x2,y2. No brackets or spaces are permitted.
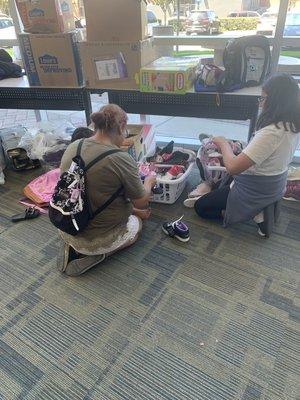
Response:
243,122,300,175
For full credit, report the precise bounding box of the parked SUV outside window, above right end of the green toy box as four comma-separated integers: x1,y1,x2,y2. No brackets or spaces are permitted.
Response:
186,10,220,35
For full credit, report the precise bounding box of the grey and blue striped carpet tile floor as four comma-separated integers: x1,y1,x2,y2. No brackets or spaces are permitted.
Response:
0,169,300,400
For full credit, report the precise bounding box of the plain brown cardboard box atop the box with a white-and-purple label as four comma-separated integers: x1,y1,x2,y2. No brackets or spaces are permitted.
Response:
84,0,148,42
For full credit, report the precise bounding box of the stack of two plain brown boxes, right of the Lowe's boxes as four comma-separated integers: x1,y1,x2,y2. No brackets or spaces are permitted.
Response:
80,0,156,89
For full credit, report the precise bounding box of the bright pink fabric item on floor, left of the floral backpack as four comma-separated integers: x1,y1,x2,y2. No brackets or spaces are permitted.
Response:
23,168,60,205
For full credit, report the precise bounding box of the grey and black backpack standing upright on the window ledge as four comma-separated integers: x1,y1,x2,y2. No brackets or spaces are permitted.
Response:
217,35,271,92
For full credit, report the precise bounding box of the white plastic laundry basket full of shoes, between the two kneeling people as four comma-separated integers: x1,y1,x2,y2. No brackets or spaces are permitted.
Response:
150,147,195,204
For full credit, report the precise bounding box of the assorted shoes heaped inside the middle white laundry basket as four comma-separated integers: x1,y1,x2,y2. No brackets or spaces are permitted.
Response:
139,140,196,182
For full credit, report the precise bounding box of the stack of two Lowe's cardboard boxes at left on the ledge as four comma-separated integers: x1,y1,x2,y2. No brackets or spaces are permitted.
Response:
16,0,83,87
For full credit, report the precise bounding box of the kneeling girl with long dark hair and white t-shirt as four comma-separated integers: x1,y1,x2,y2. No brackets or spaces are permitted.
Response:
195,74,300,235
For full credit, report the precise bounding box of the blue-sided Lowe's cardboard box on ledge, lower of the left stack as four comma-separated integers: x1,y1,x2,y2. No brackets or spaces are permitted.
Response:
19,31,83,87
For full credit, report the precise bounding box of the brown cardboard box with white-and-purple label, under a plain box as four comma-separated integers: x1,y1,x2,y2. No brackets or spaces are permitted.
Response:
79,39,155,89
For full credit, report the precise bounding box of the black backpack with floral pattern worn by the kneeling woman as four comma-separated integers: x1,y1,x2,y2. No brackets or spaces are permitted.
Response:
49,139,123,236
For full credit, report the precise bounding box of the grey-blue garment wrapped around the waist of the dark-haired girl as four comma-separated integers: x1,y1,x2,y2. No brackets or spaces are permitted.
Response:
224,172,287,227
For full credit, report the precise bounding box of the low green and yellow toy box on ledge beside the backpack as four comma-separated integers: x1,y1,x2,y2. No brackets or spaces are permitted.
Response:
140,57,201,94
